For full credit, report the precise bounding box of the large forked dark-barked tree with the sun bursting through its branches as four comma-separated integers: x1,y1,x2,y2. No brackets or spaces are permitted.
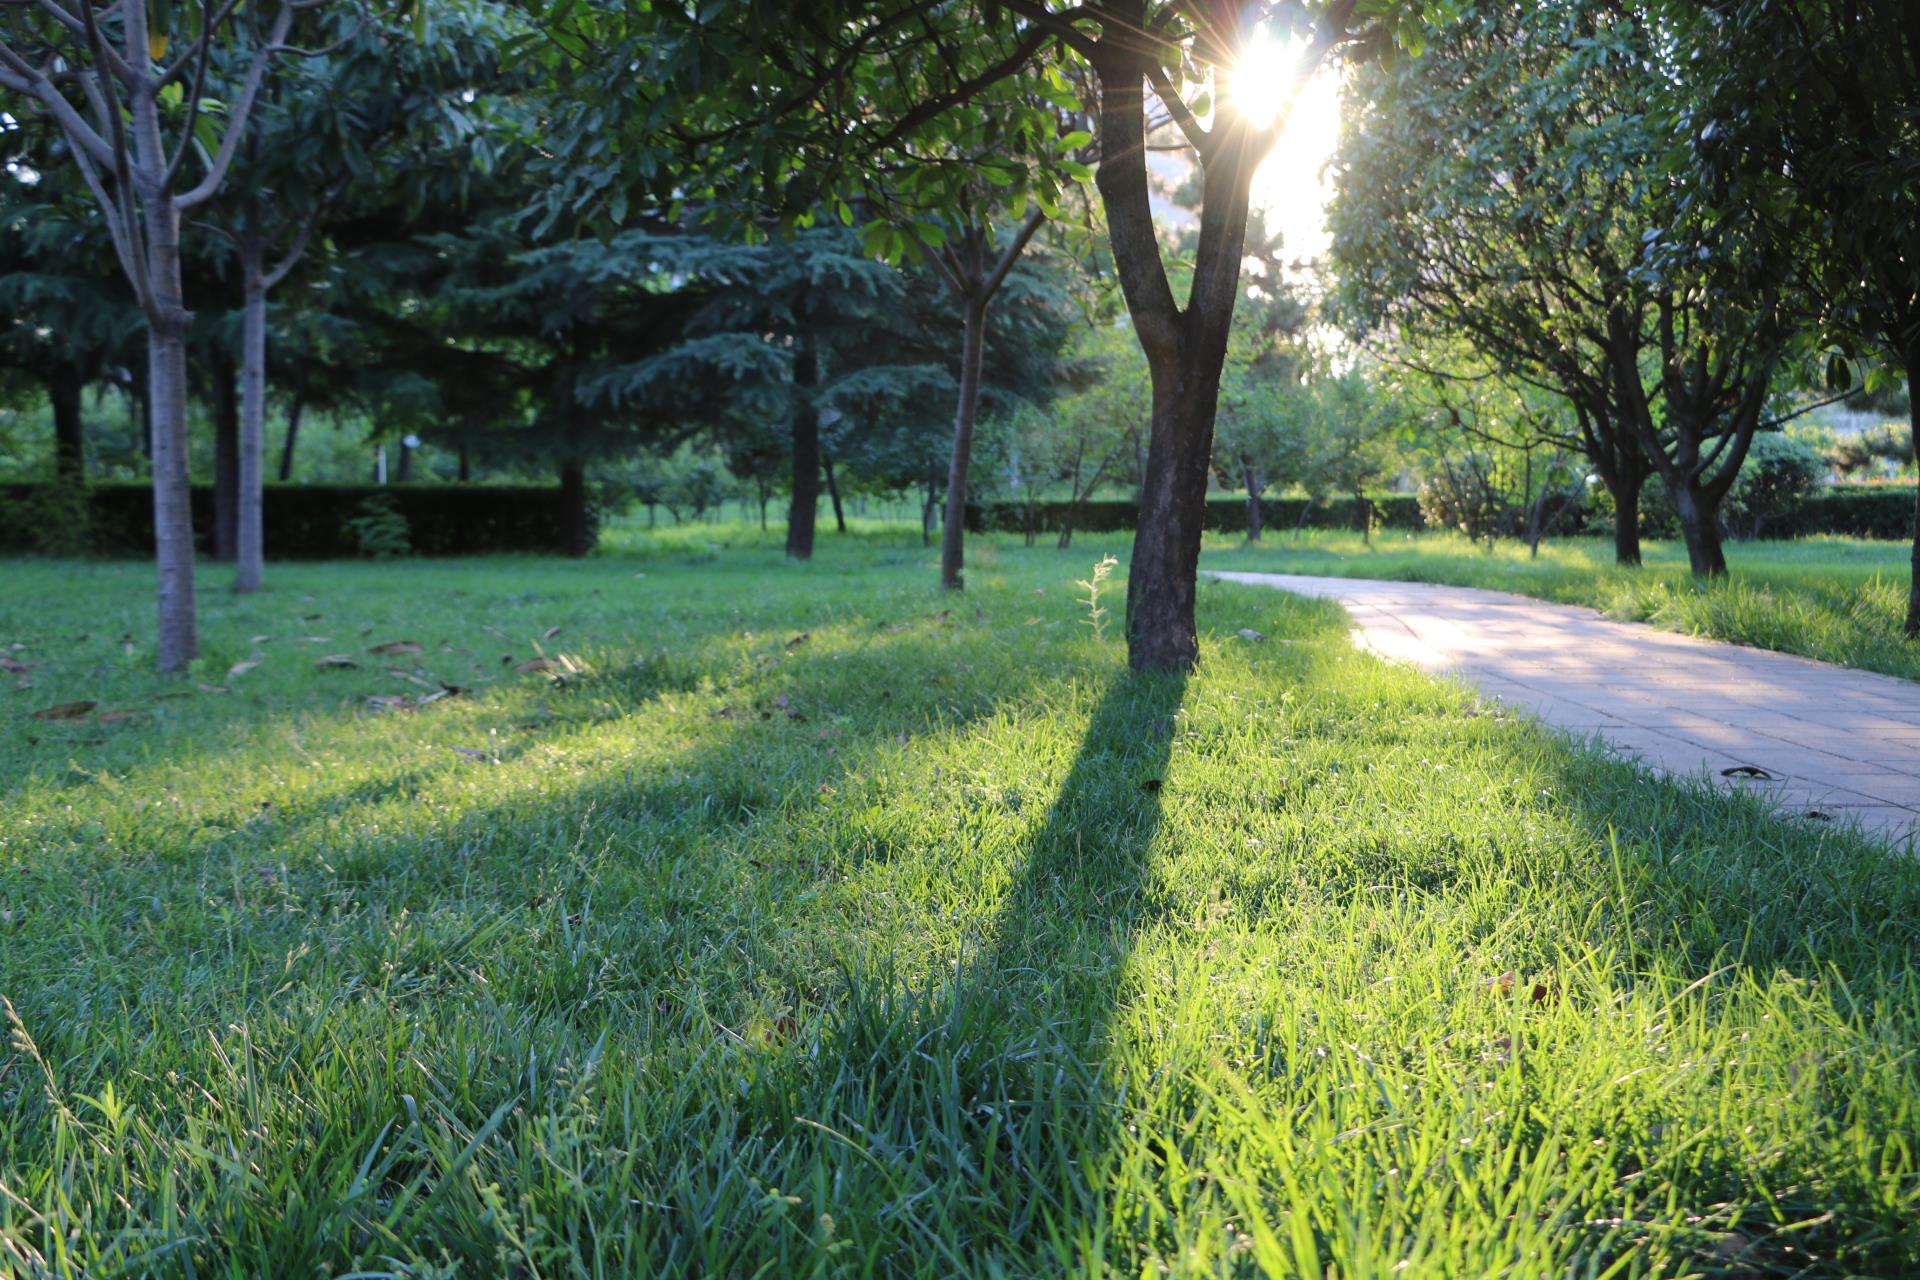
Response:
541,0,1419,668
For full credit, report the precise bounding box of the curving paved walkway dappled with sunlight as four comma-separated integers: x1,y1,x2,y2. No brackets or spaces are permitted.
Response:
1215,572,1920,841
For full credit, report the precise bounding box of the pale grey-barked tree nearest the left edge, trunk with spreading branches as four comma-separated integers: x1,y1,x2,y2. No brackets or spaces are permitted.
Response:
0,0,341,672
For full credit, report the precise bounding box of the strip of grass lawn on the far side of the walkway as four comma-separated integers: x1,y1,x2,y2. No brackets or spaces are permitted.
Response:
1206,532,1920,679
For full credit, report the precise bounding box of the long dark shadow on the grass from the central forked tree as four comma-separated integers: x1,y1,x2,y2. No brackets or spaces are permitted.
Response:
756,674,1187,1274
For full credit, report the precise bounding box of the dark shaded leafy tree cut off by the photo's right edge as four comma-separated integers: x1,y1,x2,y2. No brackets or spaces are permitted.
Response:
1689,0,1920,625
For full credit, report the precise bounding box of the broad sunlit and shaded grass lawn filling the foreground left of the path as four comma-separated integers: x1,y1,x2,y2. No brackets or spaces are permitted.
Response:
0,530,1920,1278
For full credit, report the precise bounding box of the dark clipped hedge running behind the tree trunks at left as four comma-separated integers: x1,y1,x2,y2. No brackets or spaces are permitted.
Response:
0,484,587,560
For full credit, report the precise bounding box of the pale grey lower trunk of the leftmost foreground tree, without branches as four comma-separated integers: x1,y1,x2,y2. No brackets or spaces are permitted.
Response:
146,198,200,672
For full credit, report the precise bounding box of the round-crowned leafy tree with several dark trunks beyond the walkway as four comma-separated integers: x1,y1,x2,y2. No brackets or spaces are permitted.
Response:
1334,0,1795,574
